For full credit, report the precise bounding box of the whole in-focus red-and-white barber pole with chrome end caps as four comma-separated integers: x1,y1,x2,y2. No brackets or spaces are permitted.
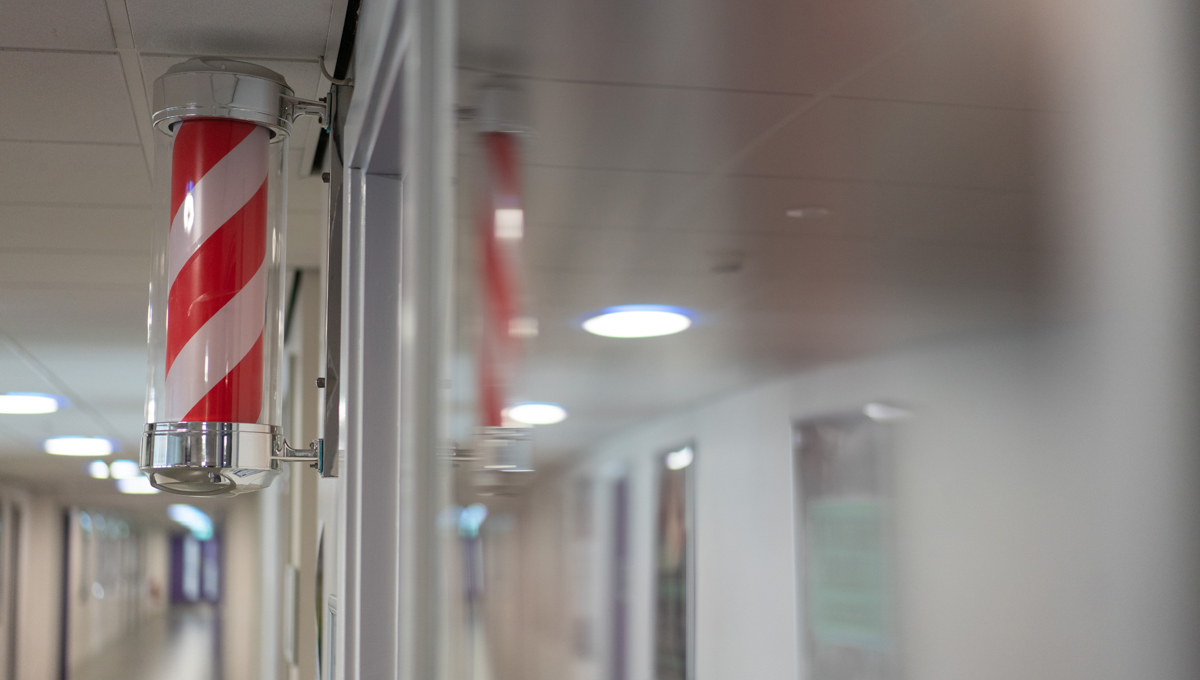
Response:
140,59,295,495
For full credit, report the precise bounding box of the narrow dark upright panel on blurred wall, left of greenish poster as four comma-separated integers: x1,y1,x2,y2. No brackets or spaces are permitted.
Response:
654,446,695,680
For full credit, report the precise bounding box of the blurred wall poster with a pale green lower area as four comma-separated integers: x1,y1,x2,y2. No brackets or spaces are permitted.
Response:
793,409,898,680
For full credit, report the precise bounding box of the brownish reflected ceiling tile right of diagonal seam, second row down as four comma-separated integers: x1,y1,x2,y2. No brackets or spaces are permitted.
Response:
734,97,1037,188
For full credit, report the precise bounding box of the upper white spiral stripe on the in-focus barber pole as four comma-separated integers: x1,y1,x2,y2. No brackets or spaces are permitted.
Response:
167,127,270,288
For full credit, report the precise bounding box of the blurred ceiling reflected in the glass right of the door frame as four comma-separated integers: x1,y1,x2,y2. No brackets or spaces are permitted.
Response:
458,0,1048,459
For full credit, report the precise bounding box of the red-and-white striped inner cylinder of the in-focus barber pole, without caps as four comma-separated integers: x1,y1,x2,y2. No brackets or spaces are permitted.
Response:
166,119,269,423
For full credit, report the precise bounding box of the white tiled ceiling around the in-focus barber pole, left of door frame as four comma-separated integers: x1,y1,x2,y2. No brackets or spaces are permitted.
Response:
0,0,344,505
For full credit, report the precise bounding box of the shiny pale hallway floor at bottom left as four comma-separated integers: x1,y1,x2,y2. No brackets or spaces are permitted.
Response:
71,607,217,680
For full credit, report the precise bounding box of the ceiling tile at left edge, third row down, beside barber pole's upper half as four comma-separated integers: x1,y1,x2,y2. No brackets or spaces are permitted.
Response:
0,142,150,205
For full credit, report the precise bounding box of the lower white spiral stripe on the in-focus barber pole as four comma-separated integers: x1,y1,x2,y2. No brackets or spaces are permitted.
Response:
166,260,266,422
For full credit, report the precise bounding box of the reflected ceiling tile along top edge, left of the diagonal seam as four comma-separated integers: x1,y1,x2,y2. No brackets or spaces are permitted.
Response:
460,0,940,94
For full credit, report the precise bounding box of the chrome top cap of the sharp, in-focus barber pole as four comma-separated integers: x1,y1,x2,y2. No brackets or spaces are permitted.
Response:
151,56,294,140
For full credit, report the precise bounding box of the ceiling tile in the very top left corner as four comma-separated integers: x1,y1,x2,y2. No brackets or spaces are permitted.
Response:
0,0,115,49
